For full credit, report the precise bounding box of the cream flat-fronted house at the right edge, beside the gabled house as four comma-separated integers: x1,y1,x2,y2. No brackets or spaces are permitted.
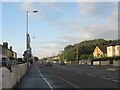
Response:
107,41,120,57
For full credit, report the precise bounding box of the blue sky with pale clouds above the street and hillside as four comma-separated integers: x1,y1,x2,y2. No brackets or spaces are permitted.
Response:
0,0,118,58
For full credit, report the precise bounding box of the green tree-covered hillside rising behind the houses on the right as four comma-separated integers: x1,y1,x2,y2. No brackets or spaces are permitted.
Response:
61,39,120,60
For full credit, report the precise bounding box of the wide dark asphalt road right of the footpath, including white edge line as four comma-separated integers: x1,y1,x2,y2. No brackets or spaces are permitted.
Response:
16,63,120,90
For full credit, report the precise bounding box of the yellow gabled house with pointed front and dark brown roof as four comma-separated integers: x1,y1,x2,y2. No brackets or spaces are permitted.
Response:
93,44,107,58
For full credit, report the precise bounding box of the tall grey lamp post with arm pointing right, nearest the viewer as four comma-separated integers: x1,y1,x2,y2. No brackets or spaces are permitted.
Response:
26,11,37,67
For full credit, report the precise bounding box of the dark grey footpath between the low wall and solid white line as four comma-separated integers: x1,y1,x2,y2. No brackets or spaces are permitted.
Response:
14,63,51,90
